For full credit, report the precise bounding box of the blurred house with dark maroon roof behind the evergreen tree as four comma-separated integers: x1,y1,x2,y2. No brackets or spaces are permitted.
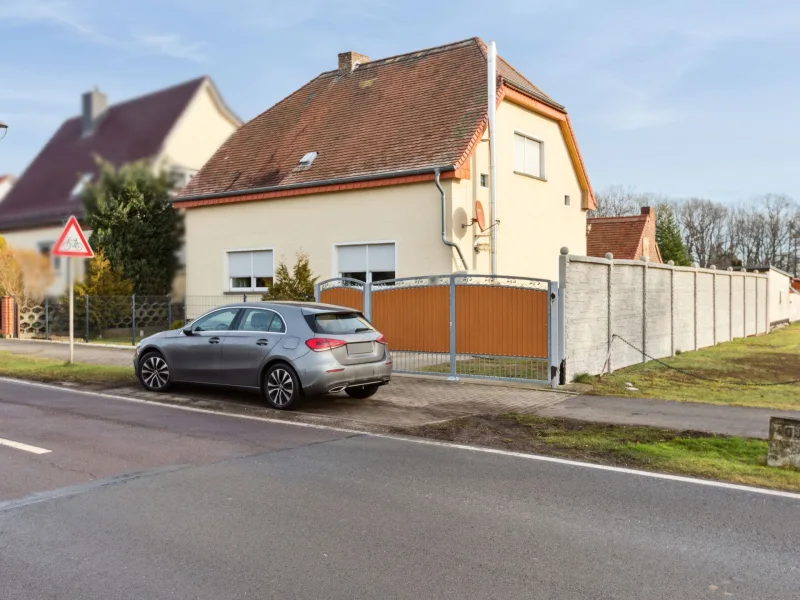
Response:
0,77,241,295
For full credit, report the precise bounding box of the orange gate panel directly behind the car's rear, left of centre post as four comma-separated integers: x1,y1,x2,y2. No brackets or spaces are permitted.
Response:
372,286,450,352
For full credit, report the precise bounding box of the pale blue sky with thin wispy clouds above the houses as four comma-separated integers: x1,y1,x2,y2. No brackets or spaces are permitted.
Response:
0,0,800,202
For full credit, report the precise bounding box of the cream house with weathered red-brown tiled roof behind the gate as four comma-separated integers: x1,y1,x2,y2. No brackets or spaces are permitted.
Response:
176,38,594,295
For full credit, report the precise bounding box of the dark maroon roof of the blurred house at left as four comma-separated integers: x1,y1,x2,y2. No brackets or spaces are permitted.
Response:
0,77,207,230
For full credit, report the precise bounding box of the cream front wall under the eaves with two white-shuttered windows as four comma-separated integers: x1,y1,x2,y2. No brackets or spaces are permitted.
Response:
186,182,456,296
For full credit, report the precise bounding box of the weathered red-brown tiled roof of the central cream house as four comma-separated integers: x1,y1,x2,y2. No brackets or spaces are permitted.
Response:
177,38,593,207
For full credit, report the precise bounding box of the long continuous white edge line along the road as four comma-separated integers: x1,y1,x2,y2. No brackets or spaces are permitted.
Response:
0,377,800,500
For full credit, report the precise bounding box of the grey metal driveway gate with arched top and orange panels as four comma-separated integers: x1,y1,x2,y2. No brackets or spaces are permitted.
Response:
317,275,560,385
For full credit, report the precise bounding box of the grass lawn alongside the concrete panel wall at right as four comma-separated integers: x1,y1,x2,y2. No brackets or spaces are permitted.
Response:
577,324,800,410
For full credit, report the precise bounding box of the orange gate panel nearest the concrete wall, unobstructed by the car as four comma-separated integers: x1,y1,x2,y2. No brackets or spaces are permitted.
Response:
456,285,549,358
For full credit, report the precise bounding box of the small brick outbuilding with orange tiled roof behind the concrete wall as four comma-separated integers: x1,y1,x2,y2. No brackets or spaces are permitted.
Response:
586,206,664,263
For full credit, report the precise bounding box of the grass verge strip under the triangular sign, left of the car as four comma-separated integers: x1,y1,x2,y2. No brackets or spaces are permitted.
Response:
0,352,137,386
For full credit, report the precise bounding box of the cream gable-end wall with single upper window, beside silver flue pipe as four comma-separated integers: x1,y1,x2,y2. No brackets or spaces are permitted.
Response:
494,100,586,281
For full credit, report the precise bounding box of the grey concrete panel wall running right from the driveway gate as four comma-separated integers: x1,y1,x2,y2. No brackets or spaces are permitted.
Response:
559,256,768,379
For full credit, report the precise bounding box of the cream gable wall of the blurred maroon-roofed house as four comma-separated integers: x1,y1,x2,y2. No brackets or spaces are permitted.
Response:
160,82,240,170
